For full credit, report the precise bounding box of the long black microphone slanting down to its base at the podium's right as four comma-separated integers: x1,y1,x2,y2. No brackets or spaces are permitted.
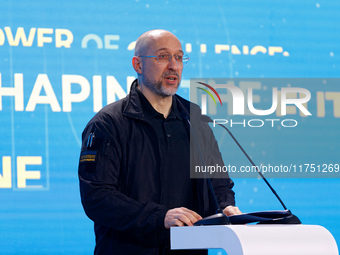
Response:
201,115,301,224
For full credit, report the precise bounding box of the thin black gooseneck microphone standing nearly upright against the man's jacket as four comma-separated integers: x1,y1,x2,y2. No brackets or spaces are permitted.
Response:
181,111,230,226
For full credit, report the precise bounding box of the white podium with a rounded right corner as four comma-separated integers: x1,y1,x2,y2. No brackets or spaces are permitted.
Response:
170,225,339,255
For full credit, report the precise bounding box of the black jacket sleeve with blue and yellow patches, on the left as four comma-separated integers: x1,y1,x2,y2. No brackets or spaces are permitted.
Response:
78,118,167,233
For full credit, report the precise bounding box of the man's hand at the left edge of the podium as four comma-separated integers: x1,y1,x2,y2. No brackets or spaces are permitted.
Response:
164,207,202,229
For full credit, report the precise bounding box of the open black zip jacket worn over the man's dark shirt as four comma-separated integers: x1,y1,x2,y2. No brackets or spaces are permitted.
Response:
79,81,235,254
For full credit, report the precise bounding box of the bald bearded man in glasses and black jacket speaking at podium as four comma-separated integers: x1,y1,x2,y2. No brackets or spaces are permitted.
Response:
79,30,240,254
